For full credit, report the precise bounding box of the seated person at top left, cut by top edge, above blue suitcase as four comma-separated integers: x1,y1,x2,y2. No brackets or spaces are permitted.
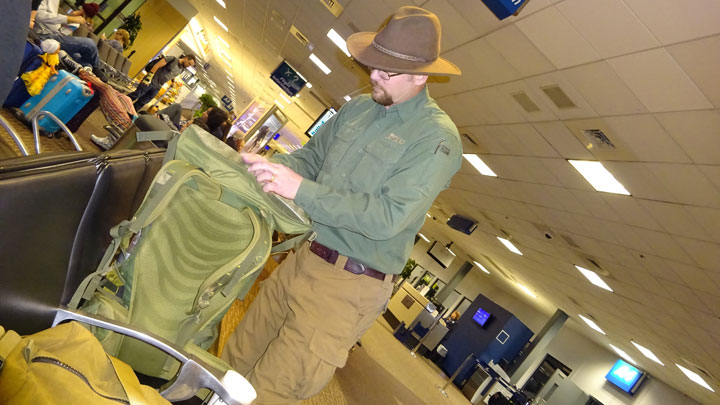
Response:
33,0,107,82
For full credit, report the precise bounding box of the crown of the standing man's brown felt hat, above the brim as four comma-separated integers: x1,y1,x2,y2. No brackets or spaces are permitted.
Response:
373,6,441,62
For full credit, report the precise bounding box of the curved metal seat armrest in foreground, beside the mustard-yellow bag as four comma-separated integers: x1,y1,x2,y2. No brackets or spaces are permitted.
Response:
53,307,257,405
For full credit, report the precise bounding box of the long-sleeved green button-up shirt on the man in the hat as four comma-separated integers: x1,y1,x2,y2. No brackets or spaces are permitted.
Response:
272,89,462,274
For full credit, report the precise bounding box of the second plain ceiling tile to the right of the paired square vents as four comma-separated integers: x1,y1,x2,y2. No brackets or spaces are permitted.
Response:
608,48,712,112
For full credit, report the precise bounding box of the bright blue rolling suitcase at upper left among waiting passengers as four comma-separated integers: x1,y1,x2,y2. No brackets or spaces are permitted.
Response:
20,70,93,134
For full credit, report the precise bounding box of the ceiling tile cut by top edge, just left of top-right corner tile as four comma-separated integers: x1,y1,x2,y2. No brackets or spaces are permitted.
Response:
557,0,660,58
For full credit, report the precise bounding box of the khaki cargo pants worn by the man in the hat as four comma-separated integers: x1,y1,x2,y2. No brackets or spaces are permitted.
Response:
221,243,392,404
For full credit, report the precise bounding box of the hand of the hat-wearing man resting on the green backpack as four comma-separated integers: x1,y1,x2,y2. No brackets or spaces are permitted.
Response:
242,153,303,200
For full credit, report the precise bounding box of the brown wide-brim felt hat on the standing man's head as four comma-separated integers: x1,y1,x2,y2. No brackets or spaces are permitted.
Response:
347,6,460,75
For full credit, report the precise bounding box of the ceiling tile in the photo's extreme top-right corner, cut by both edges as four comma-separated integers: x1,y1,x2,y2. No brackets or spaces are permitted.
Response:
625,0,720,45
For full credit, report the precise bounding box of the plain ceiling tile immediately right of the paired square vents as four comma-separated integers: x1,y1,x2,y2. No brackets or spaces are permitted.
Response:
562,60,647,115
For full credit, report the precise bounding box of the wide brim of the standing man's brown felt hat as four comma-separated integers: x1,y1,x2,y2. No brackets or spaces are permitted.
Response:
346,32,461,76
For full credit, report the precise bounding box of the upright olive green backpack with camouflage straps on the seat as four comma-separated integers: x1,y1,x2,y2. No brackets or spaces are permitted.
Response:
68,126,311,379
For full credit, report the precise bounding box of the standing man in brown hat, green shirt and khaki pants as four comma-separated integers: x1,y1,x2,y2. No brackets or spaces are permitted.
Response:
222,7,462,403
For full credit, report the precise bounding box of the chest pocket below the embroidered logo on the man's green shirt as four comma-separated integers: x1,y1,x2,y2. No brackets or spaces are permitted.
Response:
349,139,405,193
